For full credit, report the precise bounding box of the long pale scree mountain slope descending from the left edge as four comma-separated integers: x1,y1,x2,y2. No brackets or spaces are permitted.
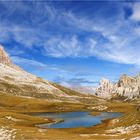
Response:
0,46,83,102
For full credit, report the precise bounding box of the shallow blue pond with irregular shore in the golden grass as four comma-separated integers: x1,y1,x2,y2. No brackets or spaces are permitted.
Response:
36,112,122,128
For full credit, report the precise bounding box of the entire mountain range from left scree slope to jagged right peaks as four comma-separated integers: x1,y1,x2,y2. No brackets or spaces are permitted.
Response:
3,46,140,102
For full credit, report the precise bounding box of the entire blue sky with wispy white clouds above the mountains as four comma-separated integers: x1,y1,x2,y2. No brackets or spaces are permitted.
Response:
0,0,140,86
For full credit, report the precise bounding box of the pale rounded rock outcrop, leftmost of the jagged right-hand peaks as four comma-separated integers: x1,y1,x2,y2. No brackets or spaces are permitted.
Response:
95,78,114,98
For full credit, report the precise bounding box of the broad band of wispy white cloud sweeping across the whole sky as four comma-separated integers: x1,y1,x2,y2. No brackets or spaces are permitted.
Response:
0,2,140,65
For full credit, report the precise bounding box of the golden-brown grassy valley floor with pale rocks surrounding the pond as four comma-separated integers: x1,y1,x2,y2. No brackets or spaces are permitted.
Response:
0,95,140,140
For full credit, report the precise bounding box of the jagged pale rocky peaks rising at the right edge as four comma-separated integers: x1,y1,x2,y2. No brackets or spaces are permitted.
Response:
95,74,140,99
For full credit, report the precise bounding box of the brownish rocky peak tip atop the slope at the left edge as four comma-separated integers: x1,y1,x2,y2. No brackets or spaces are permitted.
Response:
0,45,12,66
